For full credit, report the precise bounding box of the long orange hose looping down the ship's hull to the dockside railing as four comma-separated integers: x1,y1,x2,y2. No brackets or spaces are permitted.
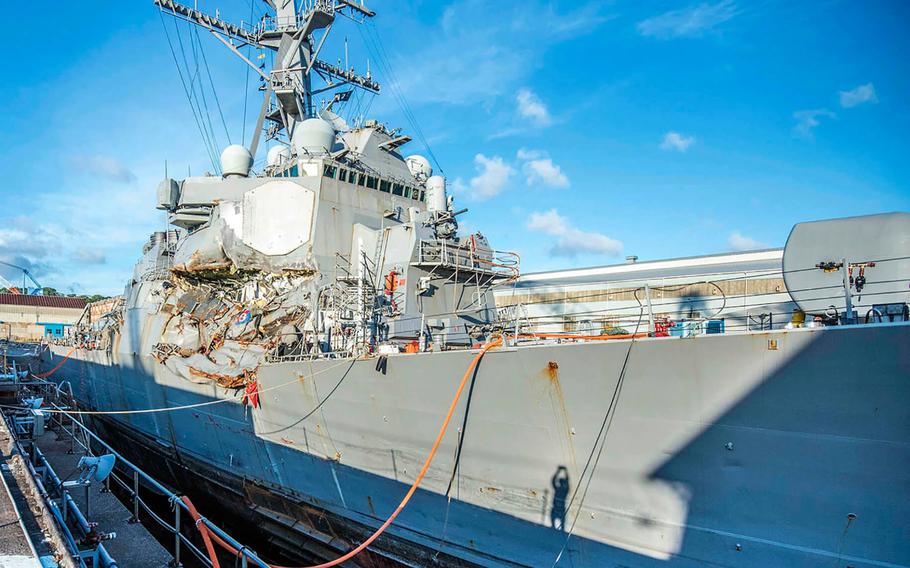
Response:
182,338,502,568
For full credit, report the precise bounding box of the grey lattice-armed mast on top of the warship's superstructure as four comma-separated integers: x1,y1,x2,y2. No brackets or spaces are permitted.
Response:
154,0,380,156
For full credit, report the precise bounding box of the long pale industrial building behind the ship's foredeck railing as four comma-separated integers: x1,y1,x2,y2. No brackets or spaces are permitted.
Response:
496,249,795,335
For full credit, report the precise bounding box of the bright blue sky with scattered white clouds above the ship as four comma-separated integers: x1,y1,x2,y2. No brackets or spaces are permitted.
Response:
0,0,910,293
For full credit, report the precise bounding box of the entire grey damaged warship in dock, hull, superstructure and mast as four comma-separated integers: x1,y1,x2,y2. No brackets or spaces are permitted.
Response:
39,0,910,568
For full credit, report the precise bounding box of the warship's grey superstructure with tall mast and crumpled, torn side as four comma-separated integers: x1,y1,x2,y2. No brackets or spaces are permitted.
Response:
139,0,518,386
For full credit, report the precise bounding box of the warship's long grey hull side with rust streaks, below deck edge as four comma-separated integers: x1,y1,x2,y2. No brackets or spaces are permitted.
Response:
49,324,910,568
